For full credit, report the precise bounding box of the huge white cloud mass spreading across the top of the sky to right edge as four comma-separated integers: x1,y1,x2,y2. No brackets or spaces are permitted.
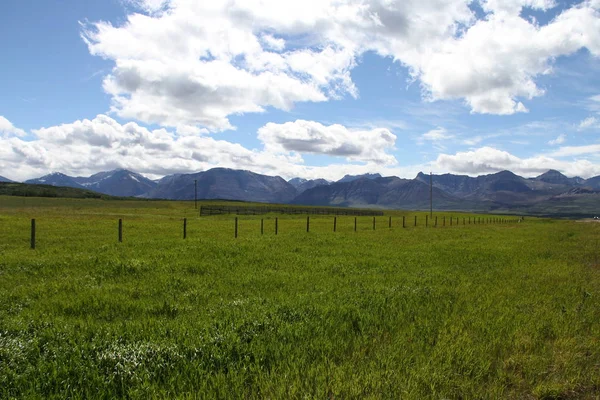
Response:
82,0,600,131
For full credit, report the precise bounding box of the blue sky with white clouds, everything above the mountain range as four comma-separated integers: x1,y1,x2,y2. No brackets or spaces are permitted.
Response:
0,0,600,181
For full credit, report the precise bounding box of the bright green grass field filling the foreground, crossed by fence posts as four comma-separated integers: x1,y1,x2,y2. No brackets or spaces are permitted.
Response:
0,197,600,399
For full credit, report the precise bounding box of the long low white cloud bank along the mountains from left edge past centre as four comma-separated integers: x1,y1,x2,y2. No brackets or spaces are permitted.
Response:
0,115,408,180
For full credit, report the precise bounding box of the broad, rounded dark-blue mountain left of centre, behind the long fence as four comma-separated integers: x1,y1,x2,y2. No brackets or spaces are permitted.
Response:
148,168,297,203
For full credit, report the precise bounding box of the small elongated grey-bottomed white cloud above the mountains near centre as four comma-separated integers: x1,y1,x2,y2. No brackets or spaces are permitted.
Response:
258,120,397,165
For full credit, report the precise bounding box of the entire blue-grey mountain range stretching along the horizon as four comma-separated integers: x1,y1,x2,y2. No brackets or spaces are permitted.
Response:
0,168,600,216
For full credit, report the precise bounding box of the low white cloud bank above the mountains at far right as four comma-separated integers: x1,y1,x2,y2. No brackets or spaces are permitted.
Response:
434,147,600,178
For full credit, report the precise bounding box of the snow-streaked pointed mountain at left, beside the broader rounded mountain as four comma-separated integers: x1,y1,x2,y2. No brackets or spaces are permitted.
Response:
73,169,157,197
